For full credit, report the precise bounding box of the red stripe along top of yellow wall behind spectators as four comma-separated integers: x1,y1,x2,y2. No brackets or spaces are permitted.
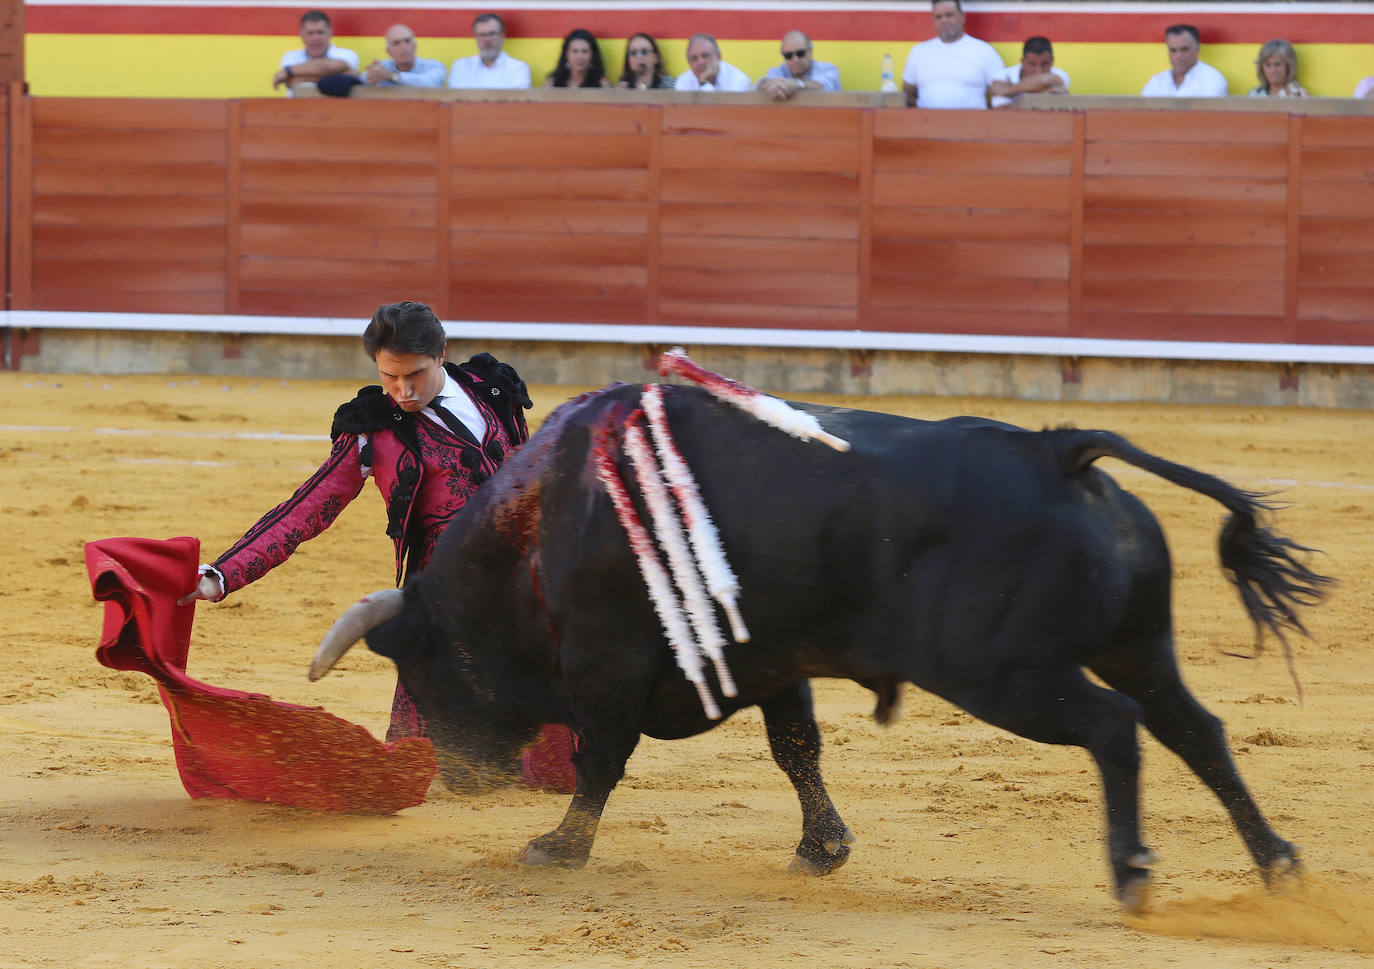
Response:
26,4,1374,44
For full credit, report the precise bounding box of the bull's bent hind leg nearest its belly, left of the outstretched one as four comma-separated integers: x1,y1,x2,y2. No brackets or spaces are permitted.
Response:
948,667,1153,910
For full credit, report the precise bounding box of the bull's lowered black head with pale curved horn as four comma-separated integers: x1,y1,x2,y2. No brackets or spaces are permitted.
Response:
309,588,539,792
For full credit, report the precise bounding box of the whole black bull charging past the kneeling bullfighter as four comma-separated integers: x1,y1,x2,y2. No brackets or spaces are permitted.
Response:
312,386,1327,904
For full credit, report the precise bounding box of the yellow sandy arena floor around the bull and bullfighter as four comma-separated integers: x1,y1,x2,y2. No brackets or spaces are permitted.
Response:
0,359,1374,969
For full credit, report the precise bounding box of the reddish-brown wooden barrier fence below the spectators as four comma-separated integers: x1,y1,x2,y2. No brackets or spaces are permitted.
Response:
5,87,1374,345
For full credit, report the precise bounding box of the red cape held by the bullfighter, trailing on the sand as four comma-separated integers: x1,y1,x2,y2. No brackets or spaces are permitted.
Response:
85,537,437,814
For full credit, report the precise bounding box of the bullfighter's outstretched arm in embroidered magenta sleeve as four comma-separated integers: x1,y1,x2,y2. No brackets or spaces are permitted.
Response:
187,434,367,599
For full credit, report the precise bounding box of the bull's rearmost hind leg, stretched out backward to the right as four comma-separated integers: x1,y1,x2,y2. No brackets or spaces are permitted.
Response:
1092,642,1298,882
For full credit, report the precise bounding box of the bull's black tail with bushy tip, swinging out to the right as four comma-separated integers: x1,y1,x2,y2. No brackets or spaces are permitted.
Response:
1054,430,1334,665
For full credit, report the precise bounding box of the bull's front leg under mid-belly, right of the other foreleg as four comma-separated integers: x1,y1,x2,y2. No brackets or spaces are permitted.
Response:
758,680,855,874
